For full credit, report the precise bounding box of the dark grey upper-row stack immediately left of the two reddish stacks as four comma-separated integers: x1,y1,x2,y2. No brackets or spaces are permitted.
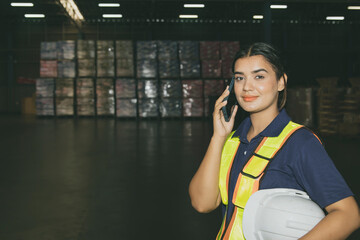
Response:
179,41,200,78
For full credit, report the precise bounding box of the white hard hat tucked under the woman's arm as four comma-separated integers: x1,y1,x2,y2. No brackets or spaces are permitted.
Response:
243,188,325,240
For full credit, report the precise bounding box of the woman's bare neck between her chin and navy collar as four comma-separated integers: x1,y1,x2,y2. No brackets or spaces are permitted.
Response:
247,108,279,142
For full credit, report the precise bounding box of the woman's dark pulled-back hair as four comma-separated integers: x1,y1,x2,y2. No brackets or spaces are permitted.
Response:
232,42,287,109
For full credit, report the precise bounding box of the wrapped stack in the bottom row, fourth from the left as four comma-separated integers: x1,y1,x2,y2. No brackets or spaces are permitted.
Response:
96,78,115,116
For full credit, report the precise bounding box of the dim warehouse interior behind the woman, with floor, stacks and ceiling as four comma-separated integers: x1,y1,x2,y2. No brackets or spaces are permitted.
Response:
0,0,360,240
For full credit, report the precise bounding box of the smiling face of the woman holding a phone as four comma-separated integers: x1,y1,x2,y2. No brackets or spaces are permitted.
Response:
234,55,286,113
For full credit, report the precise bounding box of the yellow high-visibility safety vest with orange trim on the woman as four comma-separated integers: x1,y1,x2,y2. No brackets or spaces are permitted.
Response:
216,121,303,240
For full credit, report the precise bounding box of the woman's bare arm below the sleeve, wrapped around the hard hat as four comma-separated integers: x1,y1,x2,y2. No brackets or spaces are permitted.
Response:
300,197,360,240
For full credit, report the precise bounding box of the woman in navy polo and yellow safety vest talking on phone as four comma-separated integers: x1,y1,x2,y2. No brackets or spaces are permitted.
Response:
189,43,360,240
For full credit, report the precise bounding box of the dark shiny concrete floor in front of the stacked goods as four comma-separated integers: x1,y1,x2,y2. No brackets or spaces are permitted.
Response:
0,115,360,240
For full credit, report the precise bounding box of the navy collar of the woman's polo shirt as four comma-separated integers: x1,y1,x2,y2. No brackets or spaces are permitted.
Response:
232,109,291,142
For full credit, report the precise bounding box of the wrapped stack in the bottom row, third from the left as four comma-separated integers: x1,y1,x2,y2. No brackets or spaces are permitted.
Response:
76,78,95,116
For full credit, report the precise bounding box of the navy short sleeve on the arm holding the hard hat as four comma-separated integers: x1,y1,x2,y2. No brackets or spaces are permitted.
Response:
292,130,353,208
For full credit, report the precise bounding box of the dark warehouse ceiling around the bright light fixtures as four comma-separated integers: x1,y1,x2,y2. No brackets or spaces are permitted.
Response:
0,0,360,24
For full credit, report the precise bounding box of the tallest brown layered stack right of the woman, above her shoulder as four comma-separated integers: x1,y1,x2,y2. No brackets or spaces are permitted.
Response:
316,77,341,135
